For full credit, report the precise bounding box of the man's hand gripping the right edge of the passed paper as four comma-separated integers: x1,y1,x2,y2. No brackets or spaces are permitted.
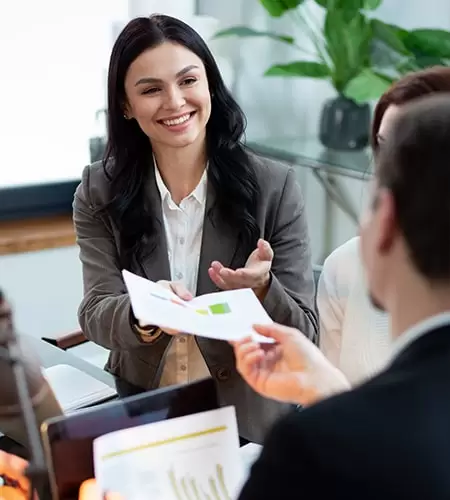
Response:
233,324,350,406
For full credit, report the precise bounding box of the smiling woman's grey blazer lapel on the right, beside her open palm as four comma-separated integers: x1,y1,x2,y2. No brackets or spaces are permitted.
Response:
197,181,239,295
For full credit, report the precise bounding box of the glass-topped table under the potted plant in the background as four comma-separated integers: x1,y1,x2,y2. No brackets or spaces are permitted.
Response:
247,137,372,261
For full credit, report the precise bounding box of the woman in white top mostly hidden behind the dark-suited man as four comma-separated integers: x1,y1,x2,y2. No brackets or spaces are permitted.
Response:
317,67,450,384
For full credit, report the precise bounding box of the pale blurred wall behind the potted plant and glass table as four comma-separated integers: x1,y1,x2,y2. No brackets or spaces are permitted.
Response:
199,0,450,259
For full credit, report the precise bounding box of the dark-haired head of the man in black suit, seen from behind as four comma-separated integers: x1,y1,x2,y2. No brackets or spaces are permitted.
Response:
361,93,450,312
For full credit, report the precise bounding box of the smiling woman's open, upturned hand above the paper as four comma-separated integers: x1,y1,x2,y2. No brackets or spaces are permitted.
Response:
208,239,273,300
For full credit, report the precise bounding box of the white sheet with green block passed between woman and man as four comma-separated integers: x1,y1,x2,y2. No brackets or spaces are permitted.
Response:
122,271,272,342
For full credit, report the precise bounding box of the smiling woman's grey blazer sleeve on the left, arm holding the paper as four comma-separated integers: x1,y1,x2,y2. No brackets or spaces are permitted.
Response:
73,167,148,350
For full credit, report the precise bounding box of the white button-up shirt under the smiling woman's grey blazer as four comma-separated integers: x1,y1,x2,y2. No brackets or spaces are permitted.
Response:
155,162,210,387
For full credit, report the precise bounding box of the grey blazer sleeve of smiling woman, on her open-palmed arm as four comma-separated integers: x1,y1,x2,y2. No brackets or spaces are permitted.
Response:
263,169,318,341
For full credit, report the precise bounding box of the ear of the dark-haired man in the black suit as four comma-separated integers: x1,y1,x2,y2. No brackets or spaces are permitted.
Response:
375,188,397,253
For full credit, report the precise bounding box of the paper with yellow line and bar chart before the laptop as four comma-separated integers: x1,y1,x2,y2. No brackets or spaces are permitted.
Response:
93,407,246,500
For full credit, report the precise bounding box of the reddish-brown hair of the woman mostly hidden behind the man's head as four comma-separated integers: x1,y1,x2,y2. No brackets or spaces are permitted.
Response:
371,66,450,152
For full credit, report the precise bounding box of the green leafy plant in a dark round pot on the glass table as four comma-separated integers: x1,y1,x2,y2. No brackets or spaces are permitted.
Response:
215,0,450,150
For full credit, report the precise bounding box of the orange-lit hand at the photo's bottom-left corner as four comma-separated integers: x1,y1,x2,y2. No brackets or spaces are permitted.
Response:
0,450,30,500
